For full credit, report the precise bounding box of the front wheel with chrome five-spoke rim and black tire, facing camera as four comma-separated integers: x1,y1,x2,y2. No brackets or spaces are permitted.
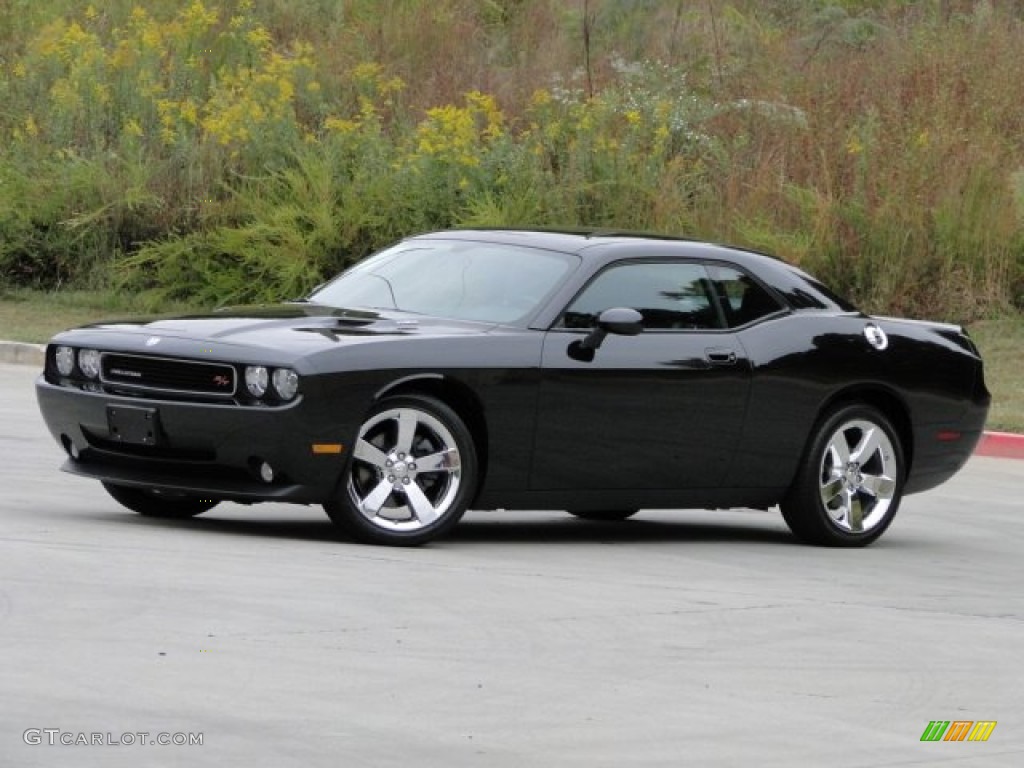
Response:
324,395,478,547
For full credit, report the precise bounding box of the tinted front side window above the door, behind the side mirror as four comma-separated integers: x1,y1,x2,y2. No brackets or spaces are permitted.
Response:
561,262,722,330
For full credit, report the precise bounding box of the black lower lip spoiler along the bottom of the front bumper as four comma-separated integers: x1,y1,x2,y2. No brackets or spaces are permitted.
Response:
60,459,323,504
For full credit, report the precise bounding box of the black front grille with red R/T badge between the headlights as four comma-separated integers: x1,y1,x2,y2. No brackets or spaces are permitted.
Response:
100,352,236,397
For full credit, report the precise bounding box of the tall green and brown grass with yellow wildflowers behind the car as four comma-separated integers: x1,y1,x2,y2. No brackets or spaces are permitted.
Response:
0,0,1024,319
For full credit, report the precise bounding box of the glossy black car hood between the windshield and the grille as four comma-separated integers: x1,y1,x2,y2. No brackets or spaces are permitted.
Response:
55,303,495,354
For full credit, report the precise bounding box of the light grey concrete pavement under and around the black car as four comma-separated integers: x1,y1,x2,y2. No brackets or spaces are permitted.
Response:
0,366,1024,768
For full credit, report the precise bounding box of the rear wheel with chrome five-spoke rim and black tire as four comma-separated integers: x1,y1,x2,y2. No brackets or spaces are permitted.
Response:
780,404,906,547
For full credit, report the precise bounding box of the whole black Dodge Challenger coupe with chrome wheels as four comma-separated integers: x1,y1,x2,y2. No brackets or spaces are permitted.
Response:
37,229,990,547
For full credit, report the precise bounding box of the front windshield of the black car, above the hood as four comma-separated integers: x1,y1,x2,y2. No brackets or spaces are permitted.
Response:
309,240,579,323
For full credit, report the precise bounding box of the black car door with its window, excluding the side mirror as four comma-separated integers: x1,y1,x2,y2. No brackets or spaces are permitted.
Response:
530,260,751,490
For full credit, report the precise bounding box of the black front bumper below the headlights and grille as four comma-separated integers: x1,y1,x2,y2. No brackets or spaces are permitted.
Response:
36,376,354,504
